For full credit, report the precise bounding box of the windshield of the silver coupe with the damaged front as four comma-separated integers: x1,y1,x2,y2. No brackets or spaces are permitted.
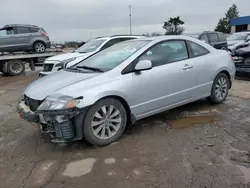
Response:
74,40,149,71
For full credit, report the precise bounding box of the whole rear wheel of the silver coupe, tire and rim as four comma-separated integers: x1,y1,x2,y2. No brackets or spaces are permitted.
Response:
209,73,230,104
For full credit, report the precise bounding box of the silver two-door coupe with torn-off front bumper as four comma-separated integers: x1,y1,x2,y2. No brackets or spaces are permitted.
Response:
18,36,235,146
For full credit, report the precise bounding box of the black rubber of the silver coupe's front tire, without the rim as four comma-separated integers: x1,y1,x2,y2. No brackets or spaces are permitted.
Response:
83,98,127,146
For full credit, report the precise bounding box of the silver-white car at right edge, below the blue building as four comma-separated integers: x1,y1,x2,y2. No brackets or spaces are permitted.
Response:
227,31,250,53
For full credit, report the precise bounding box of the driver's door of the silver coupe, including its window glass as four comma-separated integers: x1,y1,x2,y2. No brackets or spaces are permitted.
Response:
131,40,196,118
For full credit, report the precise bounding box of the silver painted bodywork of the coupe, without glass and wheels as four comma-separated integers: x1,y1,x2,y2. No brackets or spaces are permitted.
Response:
24,36,235,120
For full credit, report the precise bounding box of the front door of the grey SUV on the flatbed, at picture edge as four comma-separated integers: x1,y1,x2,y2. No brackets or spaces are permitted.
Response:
0,27,14,52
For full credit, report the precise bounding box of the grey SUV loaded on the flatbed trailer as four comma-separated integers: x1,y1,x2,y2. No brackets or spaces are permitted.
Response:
0,24,50,53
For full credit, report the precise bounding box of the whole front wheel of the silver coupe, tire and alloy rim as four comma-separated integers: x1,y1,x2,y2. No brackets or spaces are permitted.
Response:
83,98,127,146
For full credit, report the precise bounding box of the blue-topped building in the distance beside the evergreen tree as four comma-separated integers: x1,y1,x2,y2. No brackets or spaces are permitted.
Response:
231,16,250,33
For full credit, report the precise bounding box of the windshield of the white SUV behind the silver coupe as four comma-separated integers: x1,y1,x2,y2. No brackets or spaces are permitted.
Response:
75,39,107,53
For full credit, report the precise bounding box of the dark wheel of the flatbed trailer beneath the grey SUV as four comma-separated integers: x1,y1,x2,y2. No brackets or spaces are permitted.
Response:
7,60,25,76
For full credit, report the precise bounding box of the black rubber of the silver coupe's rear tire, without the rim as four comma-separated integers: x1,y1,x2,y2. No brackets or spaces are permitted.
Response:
210,73,230,104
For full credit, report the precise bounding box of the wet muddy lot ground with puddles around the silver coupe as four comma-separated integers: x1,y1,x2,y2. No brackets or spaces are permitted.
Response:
0,72,250,188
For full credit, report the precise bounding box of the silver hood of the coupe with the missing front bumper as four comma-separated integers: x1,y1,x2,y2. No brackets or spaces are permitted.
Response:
24,70,101,100
